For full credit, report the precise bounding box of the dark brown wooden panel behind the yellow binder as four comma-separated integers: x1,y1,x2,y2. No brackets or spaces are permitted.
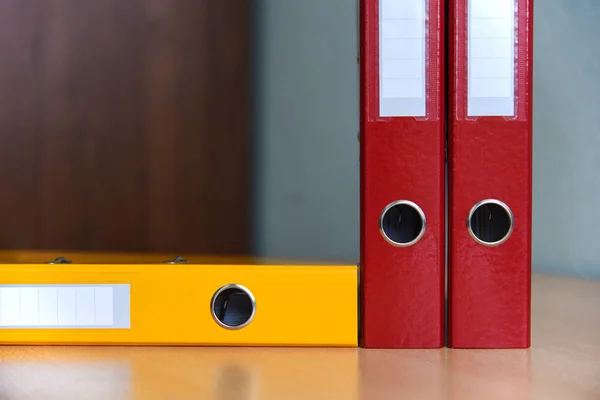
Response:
0,0,253,254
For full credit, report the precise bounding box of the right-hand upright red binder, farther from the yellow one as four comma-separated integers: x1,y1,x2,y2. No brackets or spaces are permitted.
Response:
448,0,533,348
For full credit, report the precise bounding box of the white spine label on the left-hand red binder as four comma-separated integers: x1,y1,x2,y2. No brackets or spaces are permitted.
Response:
379,0,426,117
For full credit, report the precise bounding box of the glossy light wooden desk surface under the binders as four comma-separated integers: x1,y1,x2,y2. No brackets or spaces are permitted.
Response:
0,276,600,400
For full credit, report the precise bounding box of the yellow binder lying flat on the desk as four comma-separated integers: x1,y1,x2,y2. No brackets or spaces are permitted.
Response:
0,263,358,347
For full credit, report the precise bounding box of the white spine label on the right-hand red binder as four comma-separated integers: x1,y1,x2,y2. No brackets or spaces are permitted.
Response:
467,0,515,117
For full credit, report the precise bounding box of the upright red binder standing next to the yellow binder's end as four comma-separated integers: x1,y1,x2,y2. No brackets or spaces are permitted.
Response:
360,0,445,348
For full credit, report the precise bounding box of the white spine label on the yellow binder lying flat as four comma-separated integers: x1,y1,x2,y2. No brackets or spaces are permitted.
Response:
0,285,130,329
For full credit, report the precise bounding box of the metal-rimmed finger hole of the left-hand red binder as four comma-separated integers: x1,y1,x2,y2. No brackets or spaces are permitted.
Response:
379,200,426,247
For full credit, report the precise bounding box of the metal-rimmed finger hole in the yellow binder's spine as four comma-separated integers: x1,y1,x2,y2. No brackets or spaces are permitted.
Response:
210,284,256,329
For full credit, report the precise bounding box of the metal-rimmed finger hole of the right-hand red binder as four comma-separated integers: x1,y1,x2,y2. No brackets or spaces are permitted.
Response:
467,199,514,246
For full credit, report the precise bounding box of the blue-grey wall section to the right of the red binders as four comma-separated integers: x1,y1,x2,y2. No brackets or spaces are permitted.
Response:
533,0,600,277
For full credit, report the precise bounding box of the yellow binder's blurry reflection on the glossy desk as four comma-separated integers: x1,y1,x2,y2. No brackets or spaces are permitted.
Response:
0,347,359,400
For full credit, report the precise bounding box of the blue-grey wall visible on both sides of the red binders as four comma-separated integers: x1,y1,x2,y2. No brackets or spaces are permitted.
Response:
255,0,600,277
